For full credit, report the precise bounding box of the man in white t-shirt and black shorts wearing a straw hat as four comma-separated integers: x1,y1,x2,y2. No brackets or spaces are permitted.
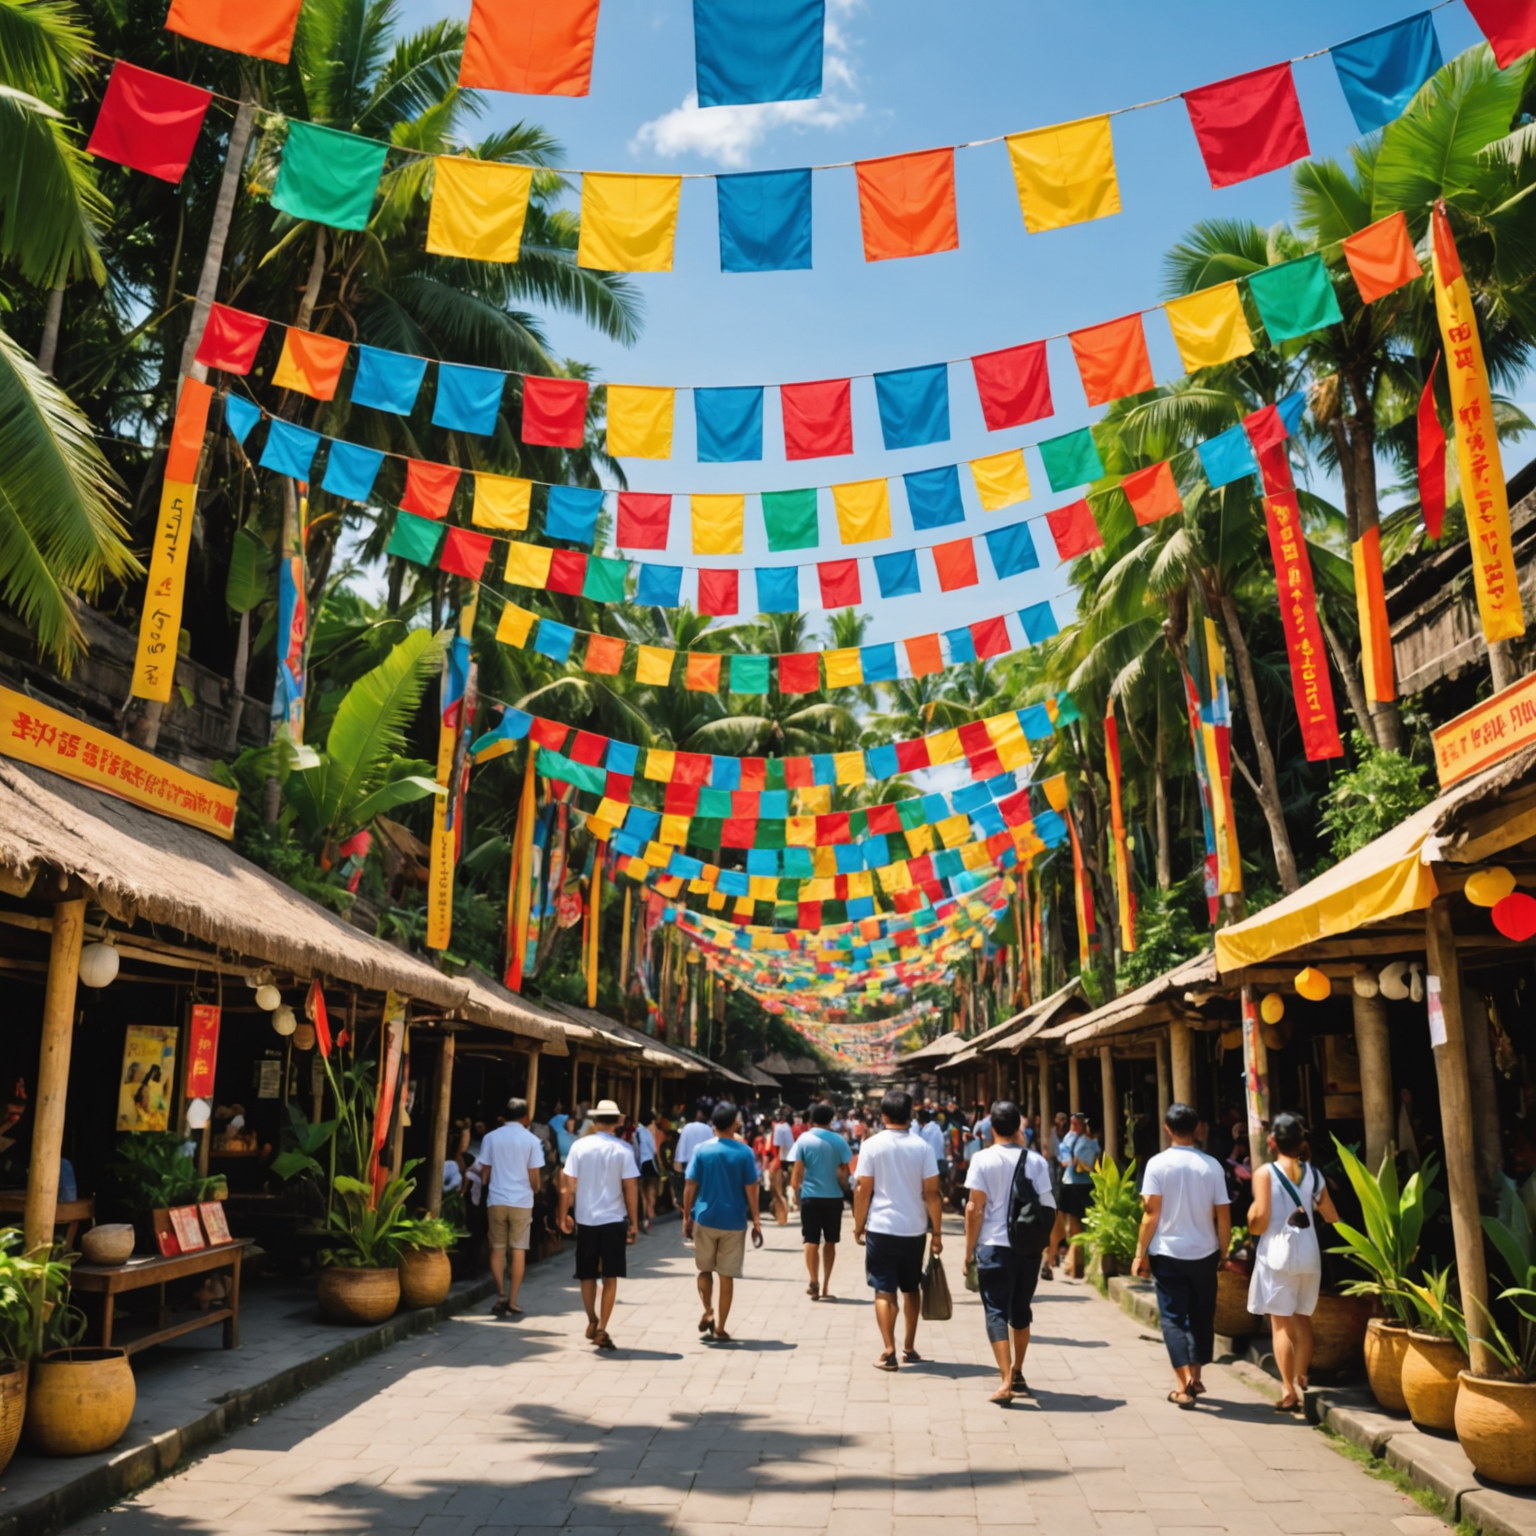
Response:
561,1098,641,1349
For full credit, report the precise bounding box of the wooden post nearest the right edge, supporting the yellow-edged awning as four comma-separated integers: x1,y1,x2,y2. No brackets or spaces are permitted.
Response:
1424,897,1495,1376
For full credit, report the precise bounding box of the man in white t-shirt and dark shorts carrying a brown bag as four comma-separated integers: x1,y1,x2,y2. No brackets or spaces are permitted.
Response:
854,1089,945,1370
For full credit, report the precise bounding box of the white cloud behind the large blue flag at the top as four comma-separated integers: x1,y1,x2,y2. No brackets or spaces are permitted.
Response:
630,0,865,170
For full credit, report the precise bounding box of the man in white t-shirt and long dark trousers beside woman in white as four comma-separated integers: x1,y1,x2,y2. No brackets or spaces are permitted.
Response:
1132,1104,1232,1409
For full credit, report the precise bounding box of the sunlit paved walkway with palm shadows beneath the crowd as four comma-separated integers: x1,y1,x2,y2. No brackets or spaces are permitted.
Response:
87,1221,1447,1536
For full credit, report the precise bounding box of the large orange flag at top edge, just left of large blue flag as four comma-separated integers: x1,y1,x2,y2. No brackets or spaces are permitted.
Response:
459,0,598,95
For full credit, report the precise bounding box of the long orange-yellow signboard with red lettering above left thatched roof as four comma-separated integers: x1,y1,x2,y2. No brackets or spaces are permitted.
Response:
0,688,240,840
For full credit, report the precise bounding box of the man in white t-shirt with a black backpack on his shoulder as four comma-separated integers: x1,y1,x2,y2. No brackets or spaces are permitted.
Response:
965,1098,1055,1402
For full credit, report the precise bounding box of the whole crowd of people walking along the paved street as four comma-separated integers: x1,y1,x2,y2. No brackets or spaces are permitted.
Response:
444,1089,1338,1412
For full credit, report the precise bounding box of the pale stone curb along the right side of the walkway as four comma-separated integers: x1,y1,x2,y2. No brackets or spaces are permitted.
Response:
1109,1275,1536,1536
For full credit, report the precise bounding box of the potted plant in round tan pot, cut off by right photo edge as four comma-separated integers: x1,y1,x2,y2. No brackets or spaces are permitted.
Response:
1456,1175,1536,1487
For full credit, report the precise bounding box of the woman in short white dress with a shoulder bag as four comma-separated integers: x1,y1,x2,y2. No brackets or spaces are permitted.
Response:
1249,1114,1339,1413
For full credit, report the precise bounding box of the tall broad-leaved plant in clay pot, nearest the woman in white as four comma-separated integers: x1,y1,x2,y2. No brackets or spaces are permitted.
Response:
1332,1137,1441,1413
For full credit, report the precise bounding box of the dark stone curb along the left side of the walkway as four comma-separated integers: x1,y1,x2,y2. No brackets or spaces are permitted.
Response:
0,1275,496,1536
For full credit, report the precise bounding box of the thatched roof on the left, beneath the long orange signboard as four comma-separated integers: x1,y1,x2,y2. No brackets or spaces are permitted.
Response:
0,759,564,1040
